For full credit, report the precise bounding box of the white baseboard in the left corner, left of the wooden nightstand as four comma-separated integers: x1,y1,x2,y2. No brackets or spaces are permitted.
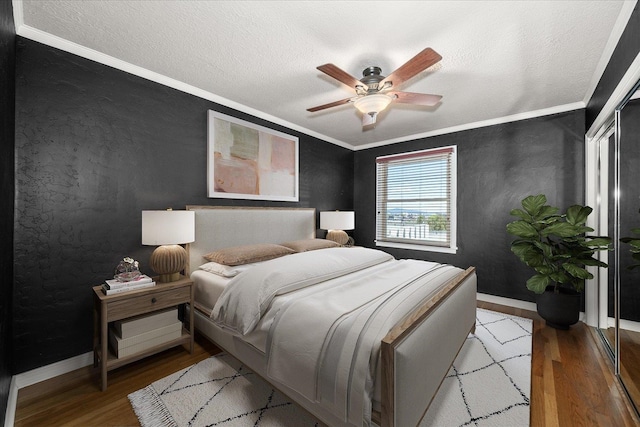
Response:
4,351,93,427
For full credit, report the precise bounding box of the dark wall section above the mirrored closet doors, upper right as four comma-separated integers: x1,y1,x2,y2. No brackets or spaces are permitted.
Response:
585,3,640,129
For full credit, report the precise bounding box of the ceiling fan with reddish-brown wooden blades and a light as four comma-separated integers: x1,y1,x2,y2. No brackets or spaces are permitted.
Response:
307,47,442,126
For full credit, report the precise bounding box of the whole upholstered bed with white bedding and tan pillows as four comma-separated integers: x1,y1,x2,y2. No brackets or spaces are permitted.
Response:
187,206,476,427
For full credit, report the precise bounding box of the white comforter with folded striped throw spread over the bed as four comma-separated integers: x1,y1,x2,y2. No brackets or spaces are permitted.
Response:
211,248,462,425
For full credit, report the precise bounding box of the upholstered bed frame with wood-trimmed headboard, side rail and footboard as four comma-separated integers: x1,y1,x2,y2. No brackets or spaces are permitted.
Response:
187,206,476,427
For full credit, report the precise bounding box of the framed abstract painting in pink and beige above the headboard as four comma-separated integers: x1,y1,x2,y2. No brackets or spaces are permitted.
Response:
207,110,298,202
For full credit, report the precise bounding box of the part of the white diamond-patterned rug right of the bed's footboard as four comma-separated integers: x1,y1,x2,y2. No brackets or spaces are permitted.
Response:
420,309,533,427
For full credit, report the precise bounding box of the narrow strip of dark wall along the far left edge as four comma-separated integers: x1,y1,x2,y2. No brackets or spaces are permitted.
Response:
0,0,16,424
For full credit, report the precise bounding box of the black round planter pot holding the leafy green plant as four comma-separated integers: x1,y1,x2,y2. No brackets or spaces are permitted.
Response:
536,286,580,330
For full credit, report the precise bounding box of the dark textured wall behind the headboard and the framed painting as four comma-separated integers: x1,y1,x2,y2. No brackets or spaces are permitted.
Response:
13,37,353,373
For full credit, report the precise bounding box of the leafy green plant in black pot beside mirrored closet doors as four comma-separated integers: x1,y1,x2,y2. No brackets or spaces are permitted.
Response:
507,194,611,329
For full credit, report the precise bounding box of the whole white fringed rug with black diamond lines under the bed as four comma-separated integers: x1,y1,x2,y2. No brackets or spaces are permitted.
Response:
129,309,532,427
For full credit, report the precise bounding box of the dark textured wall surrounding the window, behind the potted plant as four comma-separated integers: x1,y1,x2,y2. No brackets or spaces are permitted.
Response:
354,110,585,301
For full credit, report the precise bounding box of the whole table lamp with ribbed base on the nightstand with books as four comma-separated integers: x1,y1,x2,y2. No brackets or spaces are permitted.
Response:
142,209,195,283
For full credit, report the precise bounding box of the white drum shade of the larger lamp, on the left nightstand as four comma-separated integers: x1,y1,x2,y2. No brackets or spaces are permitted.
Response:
142,210,196,246
